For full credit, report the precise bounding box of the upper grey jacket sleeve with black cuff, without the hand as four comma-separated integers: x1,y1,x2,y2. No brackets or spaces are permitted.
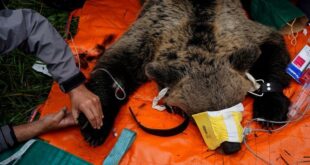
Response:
0,9,85,92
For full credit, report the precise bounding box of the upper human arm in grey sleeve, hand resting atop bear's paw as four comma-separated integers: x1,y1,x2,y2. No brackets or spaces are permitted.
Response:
0,9,103,128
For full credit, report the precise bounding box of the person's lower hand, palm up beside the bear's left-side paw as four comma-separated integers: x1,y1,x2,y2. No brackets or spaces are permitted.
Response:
39,108,76,133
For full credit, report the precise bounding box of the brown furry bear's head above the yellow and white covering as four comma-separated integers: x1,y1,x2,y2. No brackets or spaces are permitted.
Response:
146,54,252,116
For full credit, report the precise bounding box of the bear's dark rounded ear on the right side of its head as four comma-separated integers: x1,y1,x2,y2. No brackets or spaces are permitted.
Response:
229,46,261,72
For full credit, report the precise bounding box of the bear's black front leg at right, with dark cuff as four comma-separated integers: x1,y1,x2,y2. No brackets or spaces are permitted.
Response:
250,33,290,127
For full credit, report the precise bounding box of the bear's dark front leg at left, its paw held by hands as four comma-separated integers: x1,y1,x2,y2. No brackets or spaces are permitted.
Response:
79,30,154,146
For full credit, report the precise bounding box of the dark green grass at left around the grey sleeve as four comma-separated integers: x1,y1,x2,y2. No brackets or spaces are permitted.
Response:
0,0,77,125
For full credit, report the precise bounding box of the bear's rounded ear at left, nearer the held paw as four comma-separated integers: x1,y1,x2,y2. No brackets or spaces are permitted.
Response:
145,62,181,86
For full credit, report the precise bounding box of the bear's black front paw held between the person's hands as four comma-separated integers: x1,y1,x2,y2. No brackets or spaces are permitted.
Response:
78,114,105,147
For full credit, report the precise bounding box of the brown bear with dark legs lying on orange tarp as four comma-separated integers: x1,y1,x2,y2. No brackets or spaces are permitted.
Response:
79,0,290,153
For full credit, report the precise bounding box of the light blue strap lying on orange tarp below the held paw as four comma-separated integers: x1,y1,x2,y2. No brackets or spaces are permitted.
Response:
102,128,136,165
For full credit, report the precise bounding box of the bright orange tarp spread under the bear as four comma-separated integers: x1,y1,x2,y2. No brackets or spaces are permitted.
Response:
41,0,310,165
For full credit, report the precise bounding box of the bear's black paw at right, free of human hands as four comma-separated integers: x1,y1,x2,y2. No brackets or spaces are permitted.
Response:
253,92,290,128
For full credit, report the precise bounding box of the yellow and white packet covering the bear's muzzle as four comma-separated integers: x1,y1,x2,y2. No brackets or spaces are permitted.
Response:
193,103,244,150
